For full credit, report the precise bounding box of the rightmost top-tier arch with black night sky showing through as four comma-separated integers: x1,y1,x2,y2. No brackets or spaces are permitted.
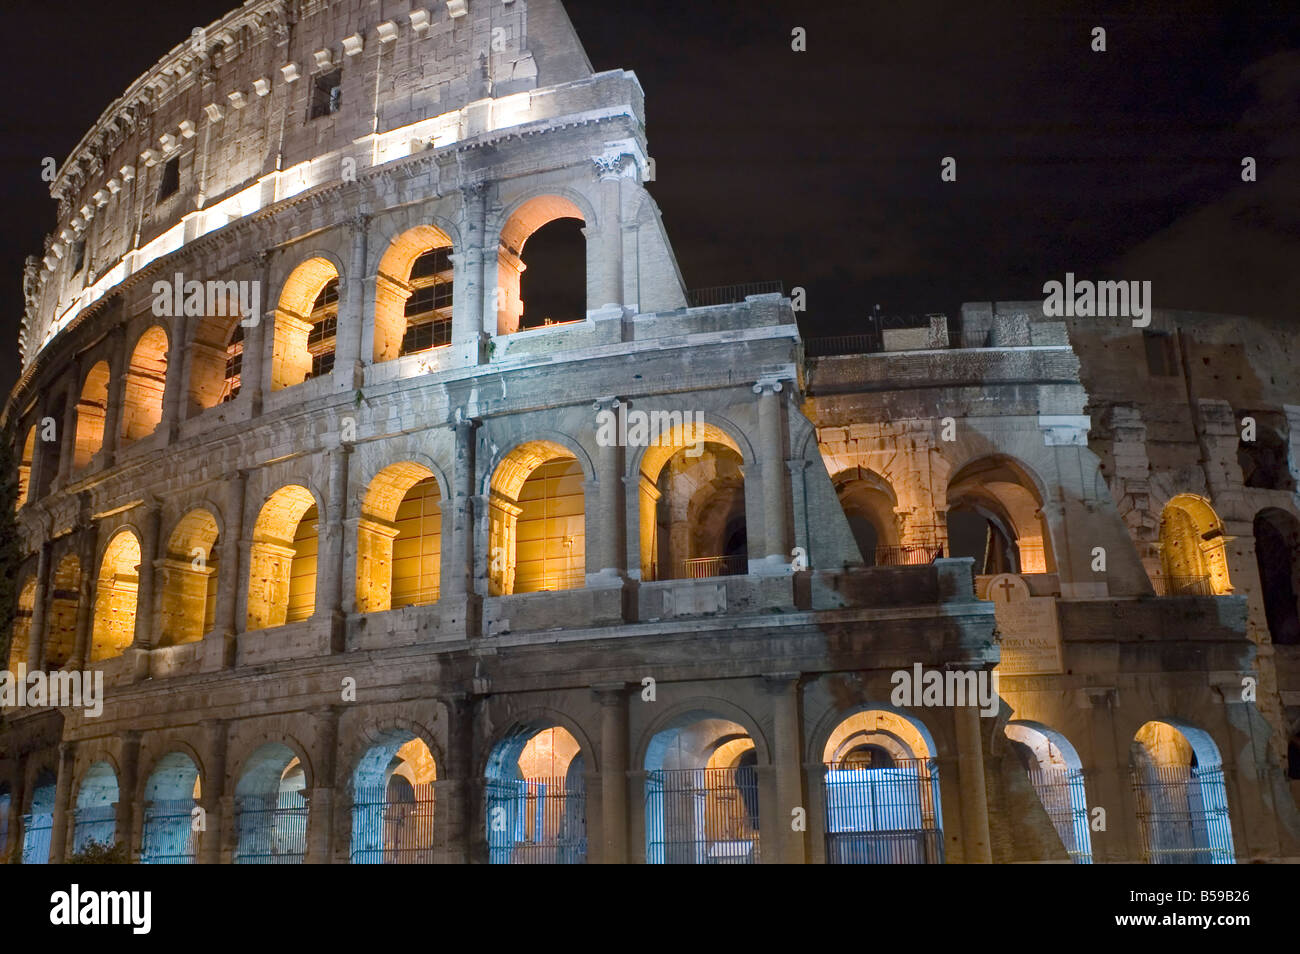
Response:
497,195,586,334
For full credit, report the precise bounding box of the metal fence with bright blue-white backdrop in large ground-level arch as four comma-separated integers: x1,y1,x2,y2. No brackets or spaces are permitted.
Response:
826,759,944,864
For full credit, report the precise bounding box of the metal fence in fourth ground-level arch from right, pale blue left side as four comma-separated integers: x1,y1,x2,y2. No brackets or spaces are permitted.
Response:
646,766,759,864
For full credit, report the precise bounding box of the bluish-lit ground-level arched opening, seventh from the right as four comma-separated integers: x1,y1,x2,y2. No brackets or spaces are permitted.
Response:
234,742,307,864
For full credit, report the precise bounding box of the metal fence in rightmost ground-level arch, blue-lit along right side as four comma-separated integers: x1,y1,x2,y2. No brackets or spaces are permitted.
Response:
1134,766,1235,864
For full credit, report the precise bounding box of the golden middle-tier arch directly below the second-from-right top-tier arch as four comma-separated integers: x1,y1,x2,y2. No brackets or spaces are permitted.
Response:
356,461,442,612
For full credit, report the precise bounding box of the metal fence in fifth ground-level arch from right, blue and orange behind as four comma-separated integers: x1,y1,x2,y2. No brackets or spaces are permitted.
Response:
488,776,586,864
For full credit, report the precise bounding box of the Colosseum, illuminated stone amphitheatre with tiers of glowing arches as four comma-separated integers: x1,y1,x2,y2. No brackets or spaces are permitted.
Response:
0,0,1300,864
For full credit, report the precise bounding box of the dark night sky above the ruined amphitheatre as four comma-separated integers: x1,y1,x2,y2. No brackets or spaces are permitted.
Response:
0,0,1300,400
